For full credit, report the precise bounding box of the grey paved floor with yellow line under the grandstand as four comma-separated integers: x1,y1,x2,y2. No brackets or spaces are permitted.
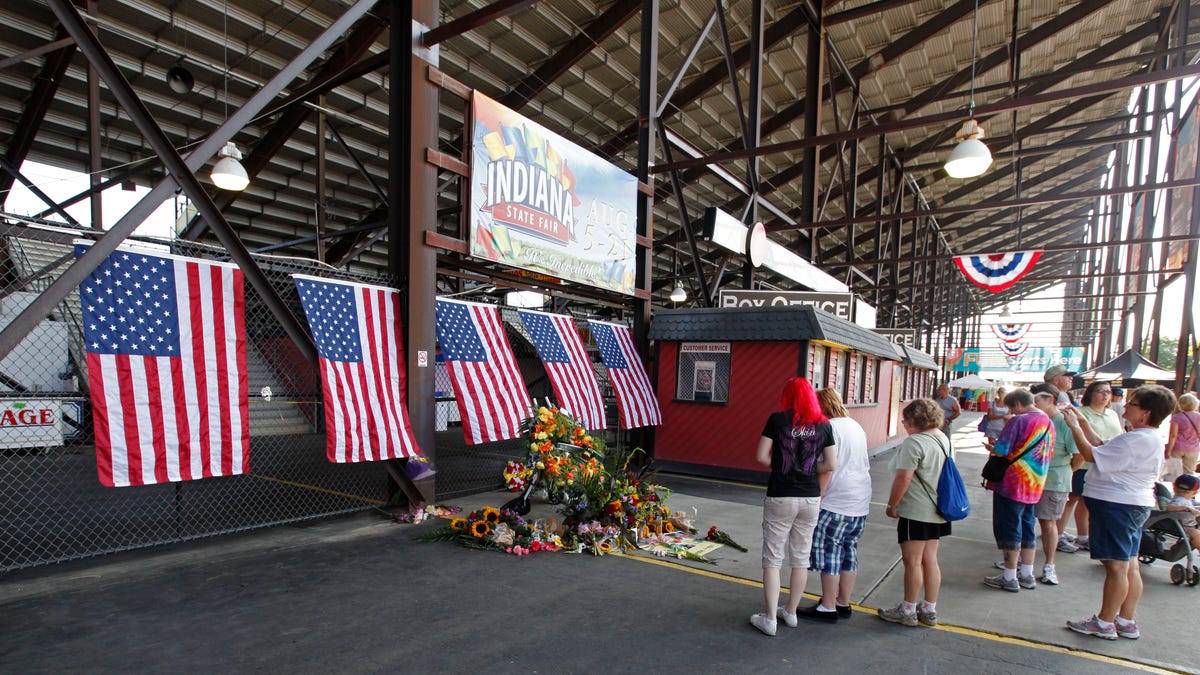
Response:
0,416,1200,674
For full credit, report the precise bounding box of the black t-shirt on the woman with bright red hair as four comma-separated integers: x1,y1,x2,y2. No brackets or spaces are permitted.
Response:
762,411,834,497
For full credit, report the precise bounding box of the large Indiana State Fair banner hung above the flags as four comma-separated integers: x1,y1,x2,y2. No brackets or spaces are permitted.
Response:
470,91,637,295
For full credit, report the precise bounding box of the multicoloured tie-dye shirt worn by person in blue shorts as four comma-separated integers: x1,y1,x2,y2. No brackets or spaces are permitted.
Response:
988,410,1054,504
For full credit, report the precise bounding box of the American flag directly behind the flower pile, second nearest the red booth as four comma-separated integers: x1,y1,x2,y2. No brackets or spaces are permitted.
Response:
517,310,605,429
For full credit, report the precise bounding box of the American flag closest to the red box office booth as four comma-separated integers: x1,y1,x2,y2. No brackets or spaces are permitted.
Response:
588,321,662,429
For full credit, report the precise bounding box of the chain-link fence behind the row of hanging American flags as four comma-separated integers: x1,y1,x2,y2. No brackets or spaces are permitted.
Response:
0,233,633,571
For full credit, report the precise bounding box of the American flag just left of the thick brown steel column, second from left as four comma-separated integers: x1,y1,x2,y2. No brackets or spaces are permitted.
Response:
292,274,421,464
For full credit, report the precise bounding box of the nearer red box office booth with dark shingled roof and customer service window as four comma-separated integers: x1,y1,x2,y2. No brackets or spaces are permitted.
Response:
649,305,936,480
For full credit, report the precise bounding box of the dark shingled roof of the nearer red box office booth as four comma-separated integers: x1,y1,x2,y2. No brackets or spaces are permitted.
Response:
649,305,899,360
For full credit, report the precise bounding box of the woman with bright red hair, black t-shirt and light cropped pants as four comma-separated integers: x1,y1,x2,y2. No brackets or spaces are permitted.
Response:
750,377,838,635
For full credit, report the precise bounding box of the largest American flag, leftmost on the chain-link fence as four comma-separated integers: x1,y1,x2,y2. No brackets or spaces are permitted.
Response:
76,244,250,486
